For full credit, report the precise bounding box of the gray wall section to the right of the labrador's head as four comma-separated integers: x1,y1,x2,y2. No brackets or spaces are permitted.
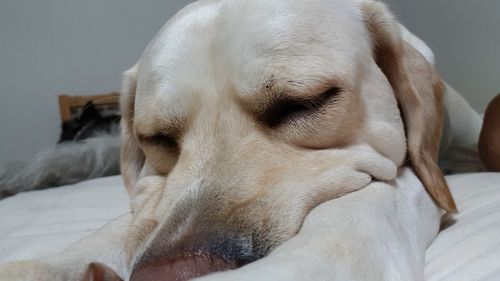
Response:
385,0,500,112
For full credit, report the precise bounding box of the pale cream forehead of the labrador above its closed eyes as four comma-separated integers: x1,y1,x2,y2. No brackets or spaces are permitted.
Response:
138,0,370,110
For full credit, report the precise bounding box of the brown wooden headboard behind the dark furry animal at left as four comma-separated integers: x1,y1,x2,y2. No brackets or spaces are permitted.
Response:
59,93,120,123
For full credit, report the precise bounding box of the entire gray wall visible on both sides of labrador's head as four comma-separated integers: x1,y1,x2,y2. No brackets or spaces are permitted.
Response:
0,0,500,163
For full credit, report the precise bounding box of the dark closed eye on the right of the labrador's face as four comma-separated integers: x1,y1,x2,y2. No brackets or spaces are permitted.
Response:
259,87,342,128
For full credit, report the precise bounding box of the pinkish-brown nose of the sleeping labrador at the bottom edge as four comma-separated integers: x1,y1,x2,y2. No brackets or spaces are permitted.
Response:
130,255,238,281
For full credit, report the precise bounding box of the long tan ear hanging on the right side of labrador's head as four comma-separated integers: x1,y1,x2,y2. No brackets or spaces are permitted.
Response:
362,1,457,212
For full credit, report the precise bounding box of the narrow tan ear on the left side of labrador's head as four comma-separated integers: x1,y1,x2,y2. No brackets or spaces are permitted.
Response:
120,65,145,197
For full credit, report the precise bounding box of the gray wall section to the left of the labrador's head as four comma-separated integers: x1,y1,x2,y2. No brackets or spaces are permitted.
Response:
0,0,191,163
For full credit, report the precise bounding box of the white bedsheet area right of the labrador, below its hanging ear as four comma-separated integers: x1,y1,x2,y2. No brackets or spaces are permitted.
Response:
426,173,500,281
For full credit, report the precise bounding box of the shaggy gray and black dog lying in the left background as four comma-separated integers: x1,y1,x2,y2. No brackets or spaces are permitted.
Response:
0,102,121,199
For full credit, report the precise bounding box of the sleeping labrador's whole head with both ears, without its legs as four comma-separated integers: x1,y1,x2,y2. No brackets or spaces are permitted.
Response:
122,0,455,280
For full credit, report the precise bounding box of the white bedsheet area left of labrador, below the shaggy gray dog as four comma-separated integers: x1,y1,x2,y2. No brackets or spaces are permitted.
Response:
0,176,129,263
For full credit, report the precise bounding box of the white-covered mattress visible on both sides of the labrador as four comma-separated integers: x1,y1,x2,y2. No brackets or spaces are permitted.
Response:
0,173,500,281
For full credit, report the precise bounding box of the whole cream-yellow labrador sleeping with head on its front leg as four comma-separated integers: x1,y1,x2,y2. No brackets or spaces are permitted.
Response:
0,0,456,281
